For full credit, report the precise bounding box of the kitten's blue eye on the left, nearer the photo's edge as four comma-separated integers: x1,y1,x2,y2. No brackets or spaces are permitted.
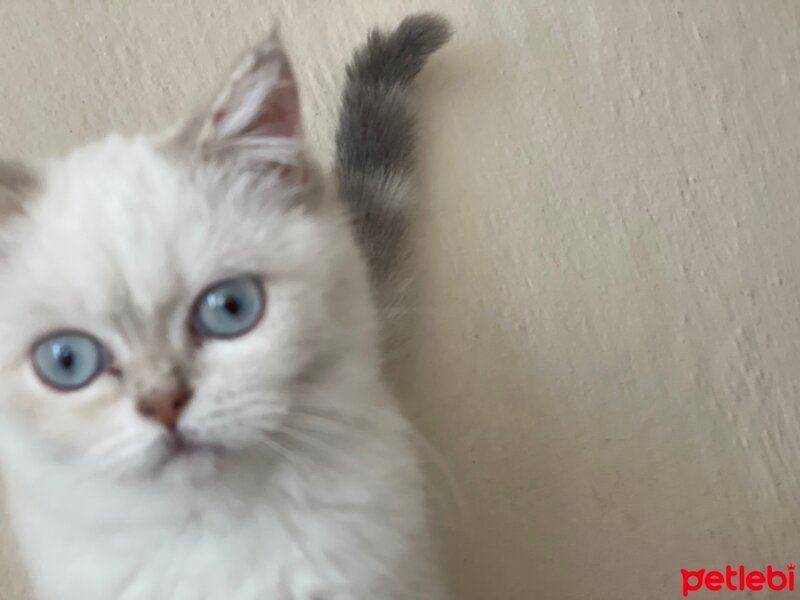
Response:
31,332,106,391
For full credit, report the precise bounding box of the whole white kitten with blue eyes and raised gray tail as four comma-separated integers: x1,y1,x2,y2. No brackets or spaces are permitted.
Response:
0,15,450,600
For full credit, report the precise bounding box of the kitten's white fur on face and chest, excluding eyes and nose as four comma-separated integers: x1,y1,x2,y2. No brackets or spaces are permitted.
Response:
0,39,442,600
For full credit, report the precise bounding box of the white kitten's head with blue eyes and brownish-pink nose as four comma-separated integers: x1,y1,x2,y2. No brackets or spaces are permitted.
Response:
0,34,374,477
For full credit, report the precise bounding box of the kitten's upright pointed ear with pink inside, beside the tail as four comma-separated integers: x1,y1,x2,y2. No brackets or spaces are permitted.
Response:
184,33,303,179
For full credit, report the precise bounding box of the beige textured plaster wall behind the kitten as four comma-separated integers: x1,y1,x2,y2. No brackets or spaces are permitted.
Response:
0,0,800,600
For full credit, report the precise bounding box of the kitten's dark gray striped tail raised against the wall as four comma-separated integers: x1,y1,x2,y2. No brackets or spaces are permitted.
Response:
336,13,451,292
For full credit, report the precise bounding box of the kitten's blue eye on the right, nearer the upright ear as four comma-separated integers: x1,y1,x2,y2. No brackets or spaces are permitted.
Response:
192,277,265,338
